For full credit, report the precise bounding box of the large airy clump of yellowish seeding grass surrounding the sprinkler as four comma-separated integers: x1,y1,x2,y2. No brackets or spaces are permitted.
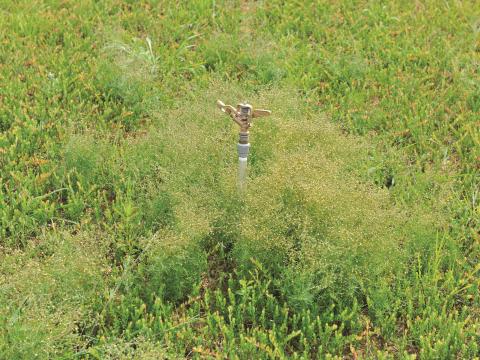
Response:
112,85,434,306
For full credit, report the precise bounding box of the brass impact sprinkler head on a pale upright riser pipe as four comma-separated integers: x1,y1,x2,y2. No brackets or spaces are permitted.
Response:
217,100,272,191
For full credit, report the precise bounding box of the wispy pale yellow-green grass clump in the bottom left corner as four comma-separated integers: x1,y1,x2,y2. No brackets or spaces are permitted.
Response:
0,232,108,359
